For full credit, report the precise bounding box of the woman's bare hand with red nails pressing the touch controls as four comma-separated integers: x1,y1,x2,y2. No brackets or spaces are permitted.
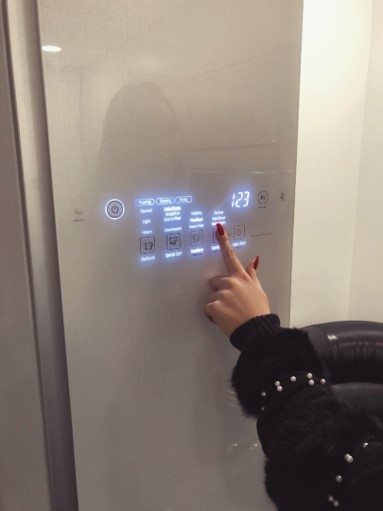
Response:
205,225,270,337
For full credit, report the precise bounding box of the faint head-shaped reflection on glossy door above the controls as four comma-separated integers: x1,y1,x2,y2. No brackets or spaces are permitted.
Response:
98,83,187,193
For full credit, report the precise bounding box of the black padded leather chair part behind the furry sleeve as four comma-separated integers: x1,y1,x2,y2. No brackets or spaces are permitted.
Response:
304,321,383,419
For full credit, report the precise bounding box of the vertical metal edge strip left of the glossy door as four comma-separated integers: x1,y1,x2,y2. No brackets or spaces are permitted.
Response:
2,0,78,511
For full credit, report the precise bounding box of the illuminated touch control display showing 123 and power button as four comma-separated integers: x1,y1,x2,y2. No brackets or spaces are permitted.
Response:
104,172,295,265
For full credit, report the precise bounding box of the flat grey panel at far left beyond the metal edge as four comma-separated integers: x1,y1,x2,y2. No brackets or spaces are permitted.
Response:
0,4,51,511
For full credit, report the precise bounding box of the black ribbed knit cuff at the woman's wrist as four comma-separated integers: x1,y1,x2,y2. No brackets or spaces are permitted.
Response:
230,314,281,351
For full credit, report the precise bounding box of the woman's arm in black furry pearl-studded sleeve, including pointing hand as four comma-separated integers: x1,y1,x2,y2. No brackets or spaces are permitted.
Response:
205,224,383,511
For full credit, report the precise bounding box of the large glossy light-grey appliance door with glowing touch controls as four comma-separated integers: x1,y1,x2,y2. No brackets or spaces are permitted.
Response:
38,0,302,511
